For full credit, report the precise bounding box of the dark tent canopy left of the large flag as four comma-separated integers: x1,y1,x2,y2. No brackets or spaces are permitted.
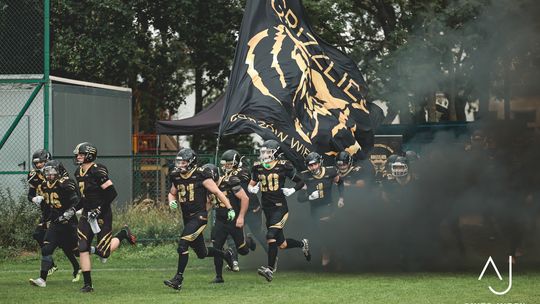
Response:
156,95,225,135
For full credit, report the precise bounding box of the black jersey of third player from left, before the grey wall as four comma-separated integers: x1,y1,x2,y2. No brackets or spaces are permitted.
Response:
75,164,110,211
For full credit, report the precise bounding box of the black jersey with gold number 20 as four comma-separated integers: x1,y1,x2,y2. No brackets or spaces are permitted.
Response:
251,160,296,207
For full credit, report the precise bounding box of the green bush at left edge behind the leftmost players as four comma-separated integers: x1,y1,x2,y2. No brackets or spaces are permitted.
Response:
0,188,40,258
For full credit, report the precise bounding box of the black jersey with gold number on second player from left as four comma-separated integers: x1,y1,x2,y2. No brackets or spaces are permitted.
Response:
41,177,79,221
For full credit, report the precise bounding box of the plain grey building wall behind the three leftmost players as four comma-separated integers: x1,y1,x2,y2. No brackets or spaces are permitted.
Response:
51,83,133,204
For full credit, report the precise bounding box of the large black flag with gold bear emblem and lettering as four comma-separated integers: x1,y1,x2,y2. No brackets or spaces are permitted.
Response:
219,0,379,165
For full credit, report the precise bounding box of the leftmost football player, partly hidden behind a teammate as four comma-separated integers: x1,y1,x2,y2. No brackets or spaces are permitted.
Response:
27,149,58,275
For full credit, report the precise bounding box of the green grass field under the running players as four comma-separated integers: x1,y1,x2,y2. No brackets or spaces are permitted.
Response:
0,245,540,304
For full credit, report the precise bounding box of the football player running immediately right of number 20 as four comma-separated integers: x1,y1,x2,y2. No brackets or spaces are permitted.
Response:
298,152,344,266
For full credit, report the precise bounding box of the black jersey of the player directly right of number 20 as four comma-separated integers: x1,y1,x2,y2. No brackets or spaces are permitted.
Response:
298,167,338,207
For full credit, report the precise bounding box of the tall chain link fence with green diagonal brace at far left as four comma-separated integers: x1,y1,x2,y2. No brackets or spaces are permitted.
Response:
0,0,48,202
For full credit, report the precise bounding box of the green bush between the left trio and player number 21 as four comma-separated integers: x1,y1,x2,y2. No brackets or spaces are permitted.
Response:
113,200,182,243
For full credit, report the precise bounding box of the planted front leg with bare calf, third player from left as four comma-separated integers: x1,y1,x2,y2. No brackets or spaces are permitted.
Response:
77,216,94,292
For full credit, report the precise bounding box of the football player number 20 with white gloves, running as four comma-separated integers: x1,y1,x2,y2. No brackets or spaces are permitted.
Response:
248,139,311,282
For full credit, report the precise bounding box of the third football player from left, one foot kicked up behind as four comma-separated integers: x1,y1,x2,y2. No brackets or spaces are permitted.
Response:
73,142,136,292
